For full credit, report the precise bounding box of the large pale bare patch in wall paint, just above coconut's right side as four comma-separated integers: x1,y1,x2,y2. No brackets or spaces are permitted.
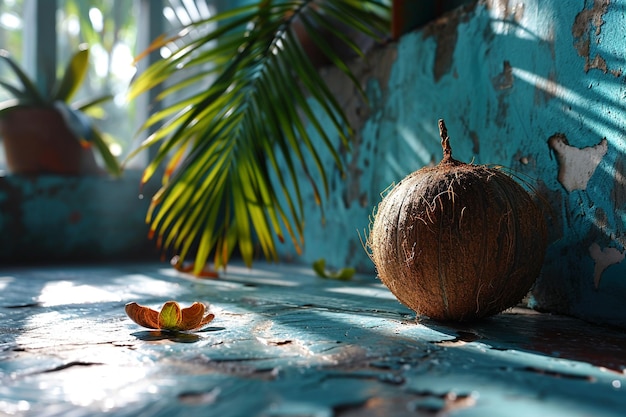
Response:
548,133,608,193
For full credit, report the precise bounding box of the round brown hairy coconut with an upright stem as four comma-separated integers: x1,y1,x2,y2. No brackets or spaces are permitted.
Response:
367,120,547,321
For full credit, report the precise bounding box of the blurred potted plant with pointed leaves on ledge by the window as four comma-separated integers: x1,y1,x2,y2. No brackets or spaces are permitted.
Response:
0,46,121,176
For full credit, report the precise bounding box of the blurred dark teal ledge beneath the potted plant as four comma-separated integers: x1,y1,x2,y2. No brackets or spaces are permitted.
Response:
0,170,156,265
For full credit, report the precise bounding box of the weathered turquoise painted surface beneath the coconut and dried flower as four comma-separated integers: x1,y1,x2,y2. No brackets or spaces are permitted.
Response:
0,264,626,417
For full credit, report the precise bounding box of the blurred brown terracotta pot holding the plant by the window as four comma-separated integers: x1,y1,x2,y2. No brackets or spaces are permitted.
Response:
0,108,103,175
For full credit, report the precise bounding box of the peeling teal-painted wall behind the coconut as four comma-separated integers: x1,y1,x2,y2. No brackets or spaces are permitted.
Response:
282,0,626,325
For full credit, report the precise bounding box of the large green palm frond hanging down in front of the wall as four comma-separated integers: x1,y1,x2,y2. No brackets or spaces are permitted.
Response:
130,0,389,273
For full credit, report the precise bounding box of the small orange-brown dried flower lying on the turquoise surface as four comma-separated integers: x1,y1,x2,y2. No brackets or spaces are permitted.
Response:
126,301,215,331
